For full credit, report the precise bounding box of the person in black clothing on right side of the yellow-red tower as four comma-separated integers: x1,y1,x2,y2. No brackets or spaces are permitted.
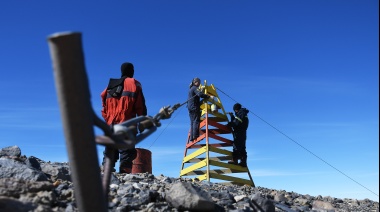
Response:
228,103,249,167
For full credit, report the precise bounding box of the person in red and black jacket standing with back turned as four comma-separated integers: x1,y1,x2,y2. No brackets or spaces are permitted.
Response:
100,62,147,173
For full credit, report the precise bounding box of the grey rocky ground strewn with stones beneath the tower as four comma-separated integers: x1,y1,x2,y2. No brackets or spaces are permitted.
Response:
0,146,379,212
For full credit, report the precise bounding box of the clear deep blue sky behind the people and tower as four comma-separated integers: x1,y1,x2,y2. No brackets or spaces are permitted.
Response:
0,0,379,201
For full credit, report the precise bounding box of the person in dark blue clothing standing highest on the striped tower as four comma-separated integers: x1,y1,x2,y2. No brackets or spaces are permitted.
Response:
187,77,213,141
